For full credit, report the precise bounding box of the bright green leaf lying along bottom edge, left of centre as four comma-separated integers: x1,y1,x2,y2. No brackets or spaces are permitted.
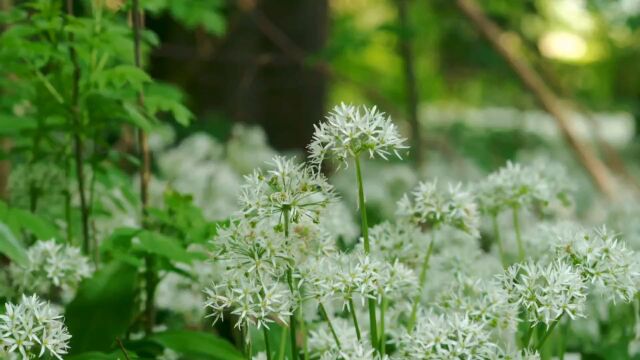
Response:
150,330,243,360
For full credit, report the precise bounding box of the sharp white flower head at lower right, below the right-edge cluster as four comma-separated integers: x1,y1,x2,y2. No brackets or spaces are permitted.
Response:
500,261,587,326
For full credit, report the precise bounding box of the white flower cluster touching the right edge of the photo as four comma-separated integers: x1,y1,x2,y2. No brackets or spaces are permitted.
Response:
556,226,640,302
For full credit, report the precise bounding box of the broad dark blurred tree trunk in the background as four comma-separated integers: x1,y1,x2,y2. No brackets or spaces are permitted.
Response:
150,0,328,149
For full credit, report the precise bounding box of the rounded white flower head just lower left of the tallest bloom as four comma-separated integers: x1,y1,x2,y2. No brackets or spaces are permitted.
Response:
240,156,335,228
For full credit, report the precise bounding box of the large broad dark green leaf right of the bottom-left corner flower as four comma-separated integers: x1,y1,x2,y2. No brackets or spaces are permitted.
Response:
65,262,138,354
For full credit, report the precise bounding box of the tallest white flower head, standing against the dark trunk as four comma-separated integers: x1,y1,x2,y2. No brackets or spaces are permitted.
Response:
308,103,407,166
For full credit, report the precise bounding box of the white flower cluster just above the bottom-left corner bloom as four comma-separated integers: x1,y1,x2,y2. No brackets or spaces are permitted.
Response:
9,239,93,294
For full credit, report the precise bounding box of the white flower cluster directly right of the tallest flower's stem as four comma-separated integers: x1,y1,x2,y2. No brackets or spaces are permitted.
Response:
397,181,480,237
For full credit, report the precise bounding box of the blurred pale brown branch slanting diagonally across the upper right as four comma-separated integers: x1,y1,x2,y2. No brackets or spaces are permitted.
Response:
456,0,615,198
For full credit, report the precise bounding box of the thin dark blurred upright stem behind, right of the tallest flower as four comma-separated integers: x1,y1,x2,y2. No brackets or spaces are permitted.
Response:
396,0,424,169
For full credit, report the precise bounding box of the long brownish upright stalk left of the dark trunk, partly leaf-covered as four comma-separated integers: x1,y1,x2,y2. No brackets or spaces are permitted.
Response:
132,0,158,335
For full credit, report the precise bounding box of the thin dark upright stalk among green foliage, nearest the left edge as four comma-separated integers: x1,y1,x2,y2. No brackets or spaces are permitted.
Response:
66,0,90,255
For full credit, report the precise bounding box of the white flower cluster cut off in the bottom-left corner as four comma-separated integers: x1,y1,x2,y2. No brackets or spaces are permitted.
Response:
0,295,71,360
